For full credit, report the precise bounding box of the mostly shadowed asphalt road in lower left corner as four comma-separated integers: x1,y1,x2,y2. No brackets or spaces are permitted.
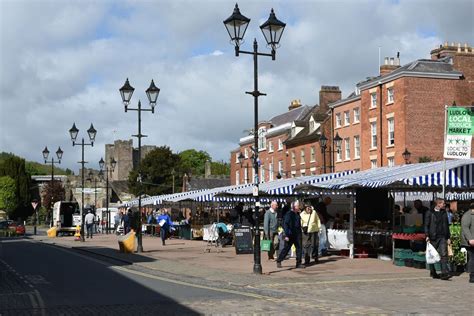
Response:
0,239,245,316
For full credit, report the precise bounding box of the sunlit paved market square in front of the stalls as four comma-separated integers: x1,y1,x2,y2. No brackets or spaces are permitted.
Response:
23,231,474,315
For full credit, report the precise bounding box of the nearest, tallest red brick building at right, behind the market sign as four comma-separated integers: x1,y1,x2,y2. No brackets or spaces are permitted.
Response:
330,44,474,171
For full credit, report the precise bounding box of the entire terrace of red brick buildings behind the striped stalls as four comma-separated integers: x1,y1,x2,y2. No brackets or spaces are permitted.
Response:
231,43,474,184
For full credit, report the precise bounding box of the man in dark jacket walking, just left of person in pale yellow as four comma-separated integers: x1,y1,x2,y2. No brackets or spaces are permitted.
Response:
277,201,305,268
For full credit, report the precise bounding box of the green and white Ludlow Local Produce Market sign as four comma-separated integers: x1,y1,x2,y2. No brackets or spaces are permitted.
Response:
444,106,474,159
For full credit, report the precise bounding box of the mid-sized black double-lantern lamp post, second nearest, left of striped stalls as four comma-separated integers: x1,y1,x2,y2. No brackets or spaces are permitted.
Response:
119,78,160,252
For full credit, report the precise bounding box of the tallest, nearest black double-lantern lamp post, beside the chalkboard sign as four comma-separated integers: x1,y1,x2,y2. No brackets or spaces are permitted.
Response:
224,4,286,274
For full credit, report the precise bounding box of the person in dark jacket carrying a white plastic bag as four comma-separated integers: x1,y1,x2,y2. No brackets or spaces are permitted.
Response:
425,199,451,280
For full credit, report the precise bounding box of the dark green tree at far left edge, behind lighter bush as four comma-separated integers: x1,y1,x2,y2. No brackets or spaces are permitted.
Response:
0,155,32,219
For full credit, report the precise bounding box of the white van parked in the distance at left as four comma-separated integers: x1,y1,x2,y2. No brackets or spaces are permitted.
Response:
53,201,82,236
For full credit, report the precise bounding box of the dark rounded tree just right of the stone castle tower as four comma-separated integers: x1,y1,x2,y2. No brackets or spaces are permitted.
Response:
128,146,181,195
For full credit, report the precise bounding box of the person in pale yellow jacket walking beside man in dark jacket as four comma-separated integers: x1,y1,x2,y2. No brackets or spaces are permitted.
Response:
301,205,320,264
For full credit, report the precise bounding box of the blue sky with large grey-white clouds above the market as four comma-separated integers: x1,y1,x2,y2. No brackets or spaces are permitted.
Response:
0,0,474,171
